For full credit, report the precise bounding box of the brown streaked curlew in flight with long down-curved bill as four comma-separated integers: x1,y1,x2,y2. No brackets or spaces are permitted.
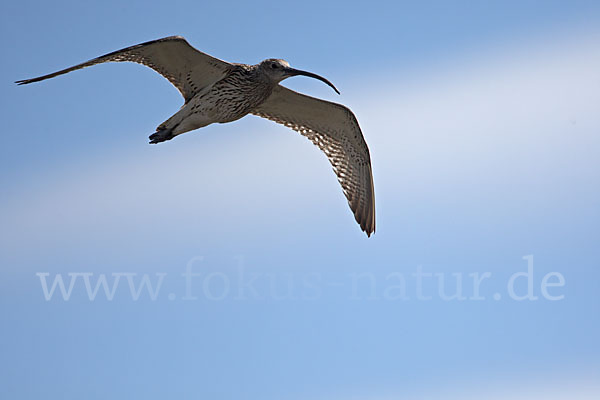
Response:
15,36,375,237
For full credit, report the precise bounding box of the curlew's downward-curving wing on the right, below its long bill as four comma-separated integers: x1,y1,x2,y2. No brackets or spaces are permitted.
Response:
252,85,375,236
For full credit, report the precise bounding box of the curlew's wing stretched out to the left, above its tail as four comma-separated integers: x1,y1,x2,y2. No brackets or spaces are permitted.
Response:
16,36,233,102
